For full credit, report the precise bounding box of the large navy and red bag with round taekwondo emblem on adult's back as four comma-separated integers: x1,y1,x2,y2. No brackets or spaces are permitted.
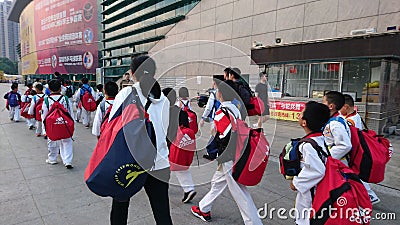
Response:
84,87,157,200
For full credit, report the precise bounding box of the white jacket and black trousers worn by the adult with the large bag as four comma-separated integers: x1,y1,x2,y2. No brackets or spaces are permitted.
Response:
109,82,172,225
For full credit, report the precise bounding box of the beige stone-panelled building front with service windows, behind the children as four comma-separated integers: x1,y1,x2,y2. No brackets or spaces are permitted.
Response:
150,0,400,132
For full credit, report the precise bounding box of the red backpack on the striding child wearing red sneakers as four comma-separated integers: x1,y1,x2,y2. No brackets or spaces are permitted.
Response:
221,107,270,186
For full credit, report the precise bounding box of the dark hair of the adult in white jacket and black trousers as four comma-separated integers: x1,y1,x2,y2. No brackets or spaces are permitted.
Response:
131,55,156,81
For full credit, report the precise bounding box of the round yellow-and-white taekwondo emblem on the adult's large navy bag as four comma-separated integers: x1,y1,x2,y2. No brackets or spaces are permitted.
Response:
114,163,146,188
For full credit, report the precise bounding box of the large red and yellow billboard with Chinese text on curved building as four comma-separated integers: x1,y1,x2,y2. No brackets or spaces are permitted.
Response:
20,0,98,74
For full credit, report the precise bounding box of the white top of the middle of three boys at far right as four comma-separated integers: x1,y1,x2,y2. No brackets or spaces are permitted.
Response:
323,113,352,165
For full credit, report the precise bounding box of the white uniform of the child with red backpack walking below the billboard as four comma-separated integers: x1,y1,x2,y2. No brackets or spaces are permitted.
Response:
42,94,73,165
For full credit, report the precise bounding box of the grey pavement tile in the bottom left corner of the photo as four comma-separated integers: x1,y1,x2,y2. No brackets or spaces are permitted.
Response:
0,196,40,224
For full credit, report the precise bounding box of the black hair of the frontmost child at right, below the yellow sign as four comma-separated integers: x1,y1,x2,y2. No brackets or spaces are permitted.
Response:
302,101,330,132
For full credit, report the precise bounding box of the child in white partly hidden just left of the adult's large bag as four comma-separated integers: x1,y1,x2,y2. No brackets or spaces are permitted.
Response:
92,81,118,138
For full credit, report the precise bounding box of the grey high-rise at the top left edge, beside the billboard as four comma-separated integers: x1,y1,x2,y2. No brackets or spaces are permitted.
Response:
0,1,19,62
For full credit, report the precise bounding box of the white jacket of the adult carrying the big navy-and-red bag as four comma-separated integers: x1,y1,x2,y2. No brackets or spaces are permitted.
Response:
110,82,169,170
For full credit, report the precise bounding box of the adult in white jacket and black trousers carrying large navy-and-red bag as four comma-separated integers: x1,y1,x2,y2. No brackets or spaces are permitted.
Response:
110,55,172,225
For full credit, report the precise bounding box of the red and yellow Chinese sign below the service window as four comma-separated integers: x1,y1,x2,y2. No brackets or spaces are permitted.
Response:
269,101,306,121
